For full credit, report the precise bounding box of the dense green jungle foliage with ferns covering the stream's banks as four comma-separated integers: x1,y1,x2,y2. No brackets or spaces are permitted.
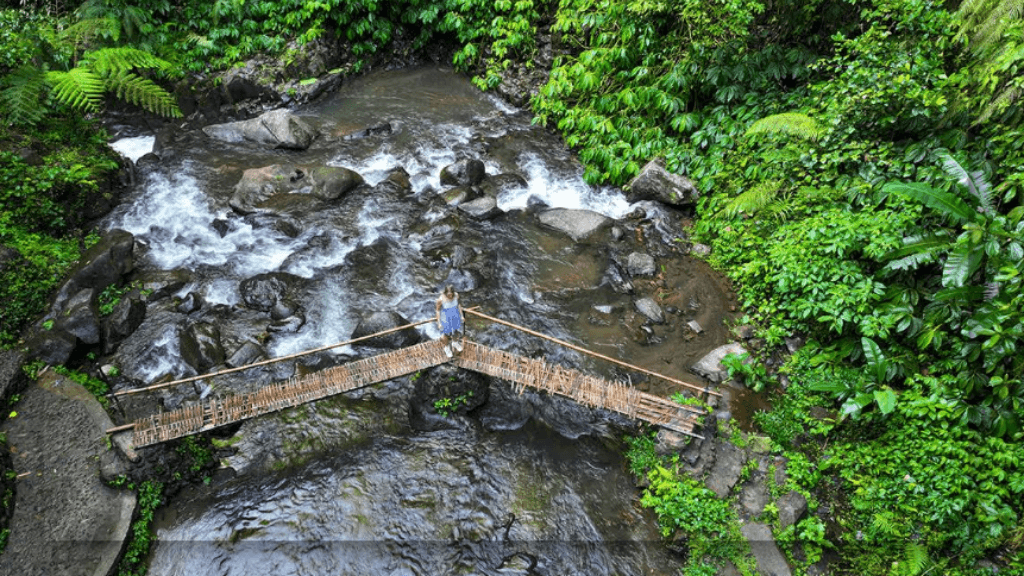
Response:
0,0,1024,574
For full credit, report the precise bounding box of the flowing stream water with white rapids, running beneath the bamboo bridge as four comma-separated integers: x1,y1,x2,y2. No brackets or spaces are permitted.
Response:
108,68,731,575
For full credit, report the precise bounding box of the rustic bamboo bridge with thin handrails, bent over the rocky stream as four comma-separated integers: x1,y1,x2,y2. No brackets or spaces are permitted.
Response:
108,308,718,448
